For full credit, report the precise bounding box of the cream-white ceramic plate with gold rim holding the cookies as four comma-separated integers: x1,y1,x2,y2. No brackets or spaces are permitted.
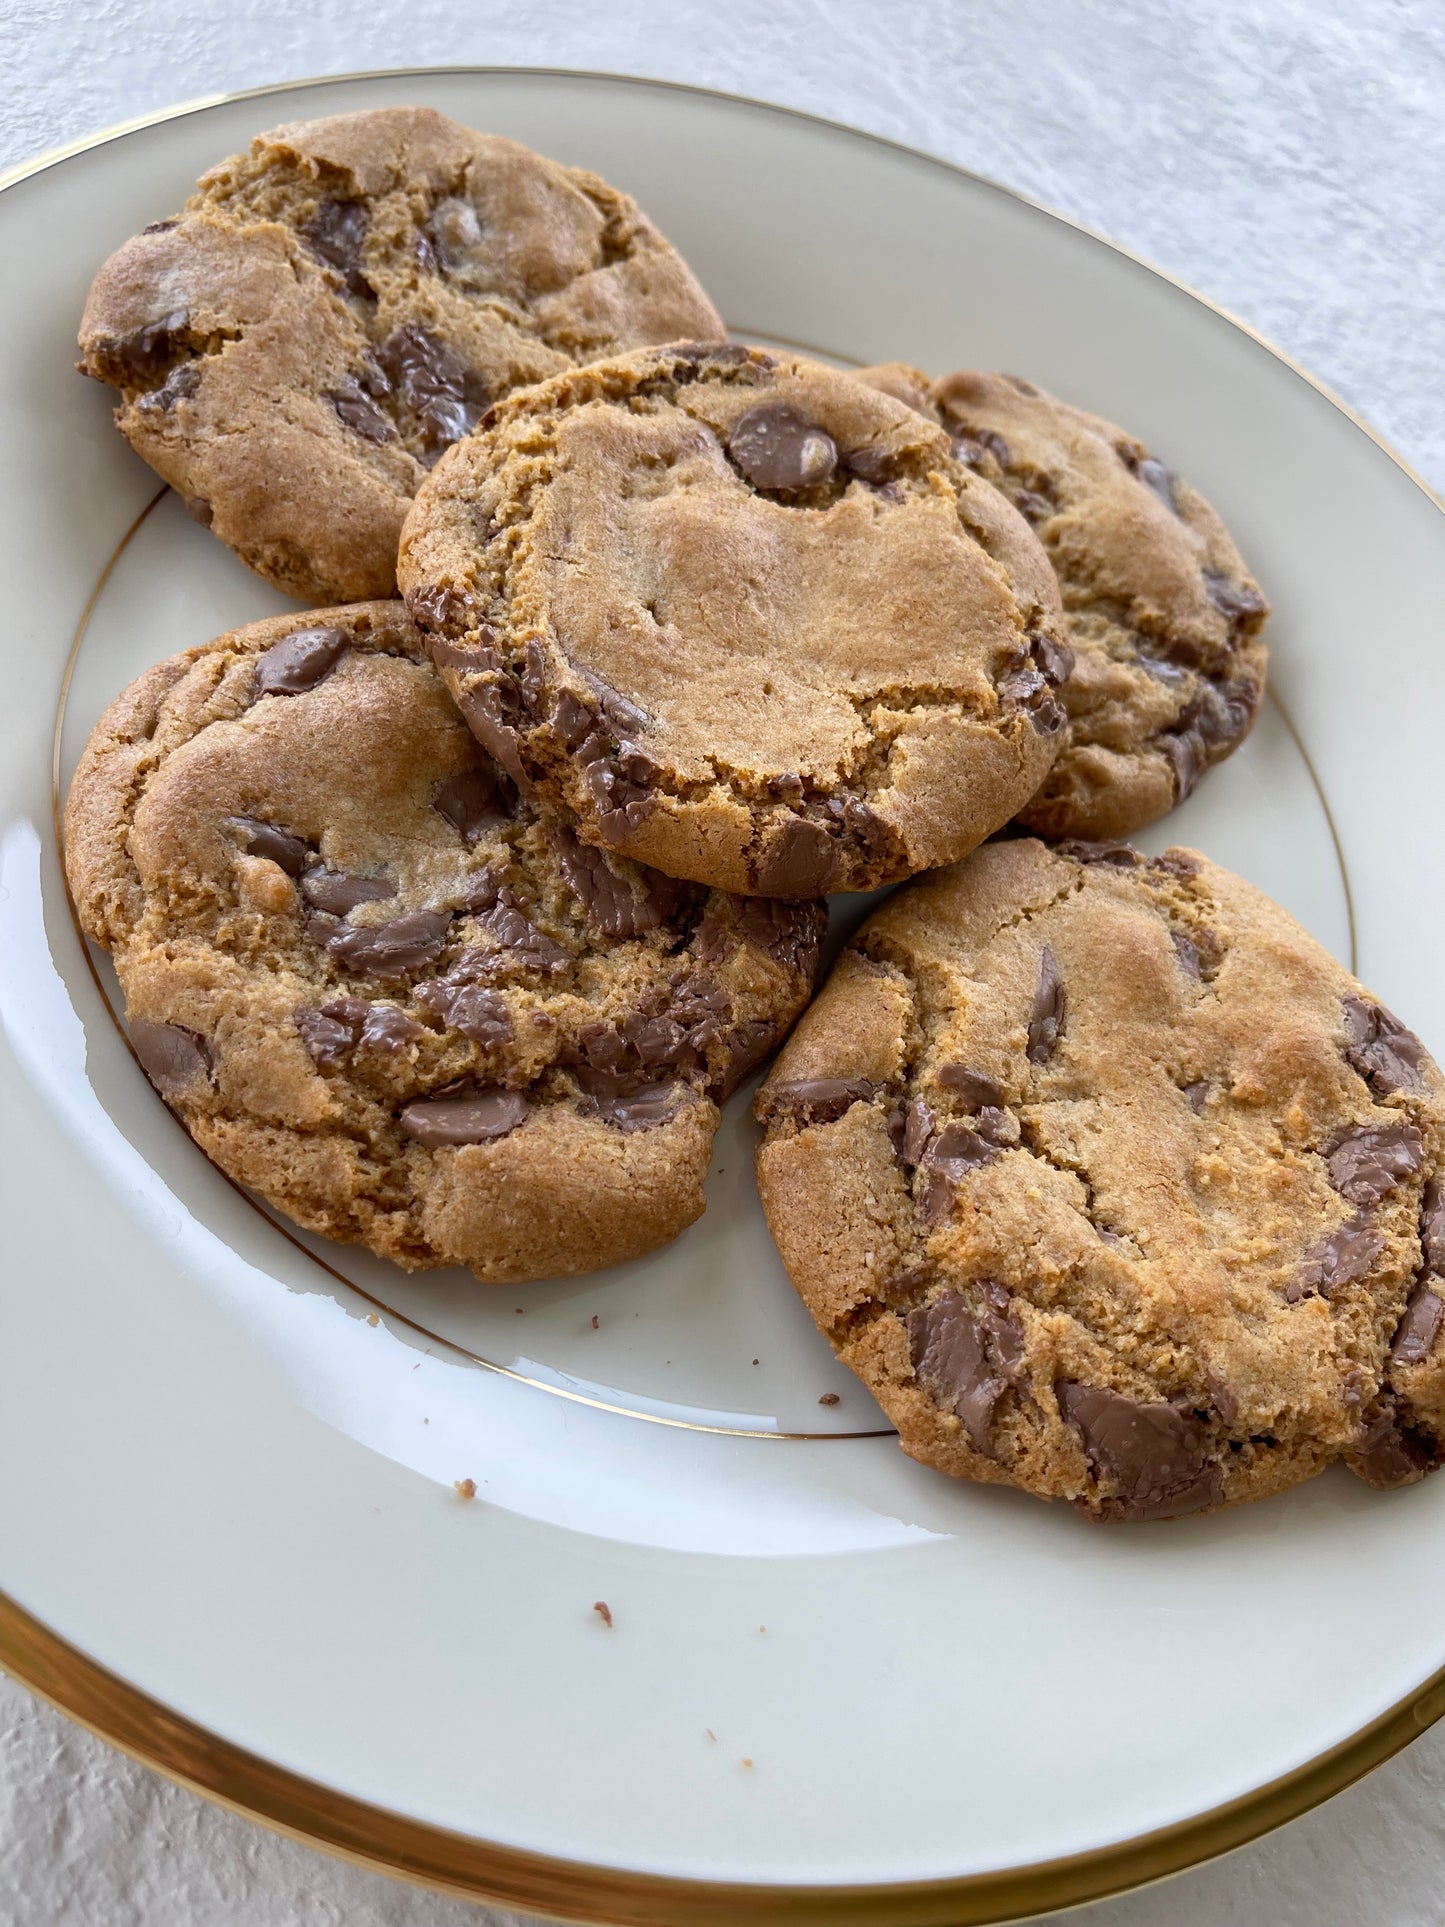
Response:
0,71,1445,1921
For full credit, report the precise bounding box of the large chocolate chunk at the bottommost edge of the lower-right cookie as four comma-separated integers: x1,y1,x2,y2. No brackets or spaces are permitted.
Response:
1054,1378,1220,1518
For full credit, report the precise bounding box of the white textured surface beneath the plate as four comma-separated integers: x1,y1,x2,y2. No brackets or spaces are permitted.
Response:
0,0,1445,1927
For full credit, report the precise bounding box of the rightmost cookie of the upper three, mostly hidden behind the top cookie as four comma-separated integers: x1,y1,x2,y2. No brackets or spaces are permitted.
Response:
863,364,1268,836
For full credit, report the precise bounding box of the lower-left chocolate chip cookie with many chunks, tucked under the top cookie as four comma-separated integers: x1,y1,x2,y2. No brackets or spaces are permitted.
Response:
66,603,823,1280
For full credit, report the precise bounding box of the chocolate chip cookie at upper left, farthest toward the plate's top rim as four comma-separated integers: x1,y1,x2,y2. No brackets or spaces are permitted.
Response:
81,108,724,601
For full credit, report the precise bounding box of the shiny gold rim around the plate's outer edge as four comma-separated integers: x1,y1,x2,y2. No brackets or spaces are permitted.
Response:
0,66,1445,1927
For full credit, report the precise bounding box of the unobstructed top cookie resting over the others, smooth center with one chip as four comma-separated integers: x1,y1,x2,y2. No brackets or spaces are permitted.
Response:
397,345,1071,898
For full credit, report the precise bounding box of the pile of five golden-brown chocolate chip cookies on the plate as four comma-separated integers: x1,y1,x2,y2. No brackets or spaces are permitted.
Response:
66,110,1445,1518
